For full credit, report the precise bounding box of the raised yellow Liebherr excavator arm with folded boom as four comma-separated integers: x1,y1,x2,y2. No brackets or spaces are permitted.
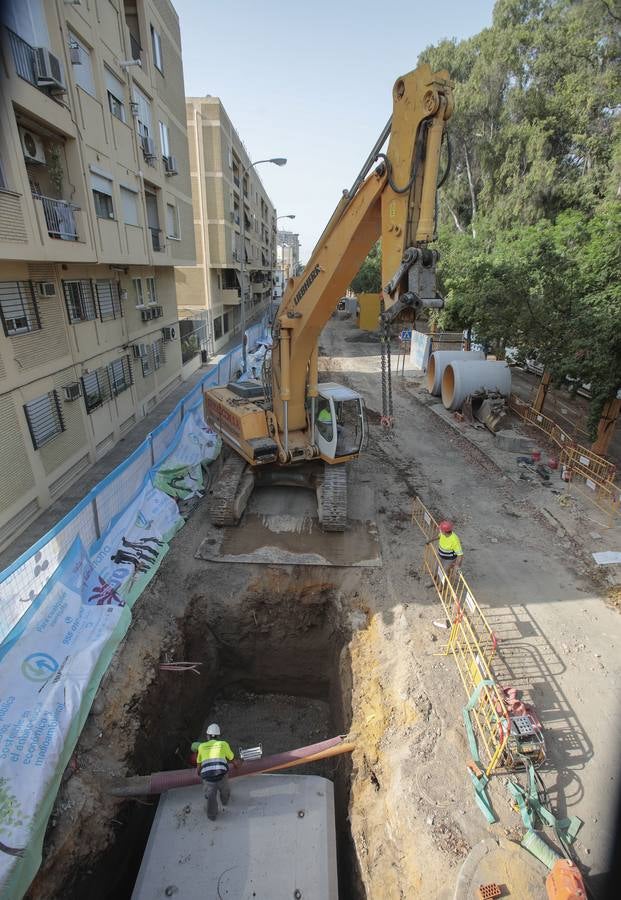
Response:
271,64,453,436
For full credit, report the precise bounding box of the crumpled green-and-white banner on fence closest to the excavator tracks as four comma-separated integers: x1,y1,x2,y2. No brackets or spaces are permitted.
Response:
153,406,222,500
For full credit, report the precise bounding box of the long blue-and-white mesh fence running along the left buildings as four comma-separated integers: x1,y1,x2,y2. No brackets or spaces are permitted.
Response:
0,322,266,643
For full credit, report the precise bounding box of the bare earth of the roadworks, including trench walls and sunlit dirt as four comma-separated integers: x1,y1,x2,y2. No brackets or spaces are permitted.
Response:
29,319,621,900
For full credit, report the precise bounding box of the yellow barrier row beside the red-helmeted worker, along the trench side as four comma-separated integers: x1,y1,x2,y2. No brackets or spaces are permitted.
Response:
412,497,508,776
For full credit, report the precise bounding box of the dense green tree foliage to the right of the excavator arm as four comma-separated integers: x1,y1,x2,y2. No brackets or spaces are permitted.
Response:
422,0,621,436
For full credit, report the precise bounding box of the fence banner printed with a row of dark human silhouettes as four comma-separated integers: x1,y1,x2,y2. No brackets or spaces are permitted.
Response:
90,474,183,606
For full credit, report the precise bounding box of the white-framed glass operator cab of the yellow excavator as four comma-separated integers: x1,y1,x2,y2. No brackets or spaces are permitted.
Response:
315,382,367,462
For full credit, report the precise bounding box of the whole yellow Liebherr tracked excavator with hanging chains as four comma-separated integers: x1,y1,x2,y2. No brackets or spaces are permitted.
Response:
204,65,453,531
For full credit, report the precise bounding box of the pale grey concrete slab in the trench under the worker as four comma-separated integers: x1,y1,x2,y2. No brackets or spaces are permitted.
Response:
132,775,338,900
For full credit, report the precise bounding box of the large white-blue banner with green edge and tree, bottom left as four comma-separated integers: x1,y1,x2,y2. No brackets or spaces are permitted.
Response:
0,538,131,897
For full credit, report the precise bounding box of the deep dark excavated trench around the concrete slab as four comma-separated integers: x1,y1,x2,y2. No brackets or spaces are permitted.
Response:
65,572,366,900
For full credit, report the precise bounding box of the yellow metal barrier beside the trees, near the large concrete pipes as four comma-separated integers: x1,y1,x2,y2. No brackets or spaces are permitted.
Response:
509,394,621,525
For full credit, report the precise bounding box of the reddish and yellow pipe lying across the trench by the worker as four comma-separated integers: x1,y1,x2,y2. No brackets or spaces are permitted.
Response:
108,736,348,797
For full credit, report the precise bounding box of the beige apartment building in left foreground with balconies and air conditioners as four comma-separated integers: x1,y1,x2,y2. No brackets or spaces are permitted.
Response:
0,0,194,549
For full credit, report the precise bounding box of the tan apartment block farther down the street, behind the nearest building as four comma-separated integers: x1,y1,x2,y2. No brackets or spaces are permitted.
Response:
175,96,276,352
